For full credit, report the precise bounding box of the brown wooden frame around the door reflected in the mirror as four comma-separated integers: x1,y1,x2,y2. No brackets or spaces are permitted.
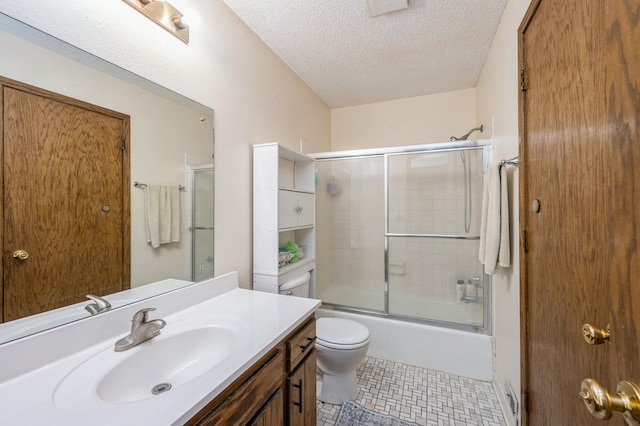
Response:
0,76,131,323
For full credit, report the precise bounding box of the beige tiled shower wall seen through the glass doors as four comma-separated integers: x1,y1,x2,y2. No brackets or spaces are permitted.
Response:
316,149,483,313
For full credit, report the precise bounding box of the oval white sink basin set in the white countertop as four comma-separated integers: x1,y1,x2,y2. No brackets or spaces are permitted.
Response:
54,319,248,407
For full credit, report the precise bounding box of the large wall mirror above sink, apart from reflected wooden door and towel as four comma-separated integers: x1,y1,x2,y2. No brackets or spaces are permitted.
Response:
0,14,214,344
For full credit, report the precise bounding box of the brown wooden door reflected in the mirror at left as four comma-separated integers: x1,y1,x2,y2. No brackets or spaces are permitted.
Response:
0,80,130,321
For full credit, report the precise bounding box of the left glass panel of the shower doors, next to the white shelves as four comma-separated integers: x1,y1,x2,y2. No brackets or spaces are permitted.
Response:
316,157,385,311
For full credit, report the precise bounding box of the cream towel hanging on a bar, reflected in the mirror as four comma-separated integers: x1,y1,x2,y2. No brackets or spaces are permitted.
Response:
145,185,180,248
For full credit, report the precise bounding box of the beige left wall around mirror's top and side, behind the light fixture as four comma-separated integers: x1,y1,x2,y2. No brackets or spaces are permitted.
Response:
0,0,330,288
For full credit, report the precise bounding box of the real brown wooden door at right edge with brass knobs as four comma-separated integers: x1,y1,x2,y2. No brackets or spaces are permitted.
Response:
519,0,640,426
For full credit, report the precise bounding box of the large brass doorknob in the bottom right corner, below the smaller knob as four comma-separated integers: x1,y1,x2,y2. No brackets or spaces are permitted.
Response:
578,379,640,426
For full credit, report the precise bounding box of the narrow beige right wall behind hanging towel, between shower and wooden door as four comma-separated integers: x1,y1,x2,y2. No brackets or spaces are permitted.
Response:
476,0,530,425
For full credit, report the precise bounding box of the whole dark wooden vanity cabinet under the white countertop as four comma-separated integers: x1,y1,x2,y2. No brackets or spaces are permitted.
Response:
186,316,316,426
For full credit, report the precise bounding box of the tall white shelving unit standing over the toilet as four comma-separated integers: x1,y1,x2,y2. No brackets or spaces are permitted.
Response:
253,142,316,294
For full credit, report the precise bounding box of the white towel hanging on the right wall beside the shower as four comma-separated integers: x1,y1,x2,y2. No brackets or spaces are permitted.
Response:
478,165,511,275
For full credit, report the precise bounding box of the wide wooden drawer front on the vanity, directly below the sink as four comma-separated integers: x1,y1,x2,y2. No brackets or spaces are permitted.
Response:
197,350,284,425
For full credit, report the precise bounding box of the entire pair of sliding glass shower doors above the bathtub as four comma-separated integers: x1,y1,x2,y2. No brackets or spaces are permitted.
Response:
315,141,490,332
